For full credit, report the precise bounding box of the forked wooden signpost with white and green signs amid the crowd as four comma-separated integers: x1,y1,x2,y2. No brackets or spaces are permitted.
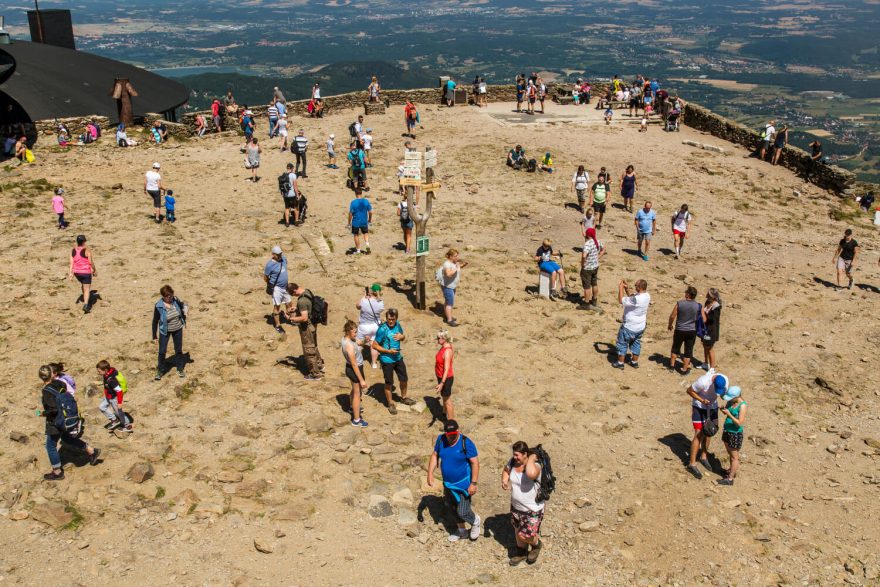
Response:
400,147,440,310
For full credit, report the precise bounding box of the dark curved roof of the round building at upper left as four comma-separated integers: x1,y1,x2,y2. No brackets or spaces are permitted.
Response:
0,40,188,122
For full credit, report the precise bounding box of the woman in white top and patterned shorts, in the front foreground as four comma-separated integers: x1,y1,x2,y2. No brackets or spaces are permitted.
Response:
501,440,544,567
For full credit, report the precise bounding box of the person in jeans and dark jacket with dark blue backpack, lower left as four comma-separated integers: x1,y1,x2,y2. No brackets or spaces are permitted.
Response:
37,365,101,481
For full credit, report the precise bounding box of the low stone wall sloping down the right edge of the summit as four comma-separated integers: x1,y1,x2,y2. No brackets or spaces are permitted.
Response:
684,104,856,195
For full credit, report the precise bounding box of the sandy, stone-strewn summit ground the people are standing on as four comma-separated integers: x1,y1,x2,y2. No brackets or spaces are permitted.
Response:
0,99,880,585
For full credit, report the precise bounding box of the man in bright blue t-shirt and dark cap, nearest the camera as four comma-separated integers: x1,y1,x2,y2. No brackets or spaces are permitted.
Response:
427,420,482,542
